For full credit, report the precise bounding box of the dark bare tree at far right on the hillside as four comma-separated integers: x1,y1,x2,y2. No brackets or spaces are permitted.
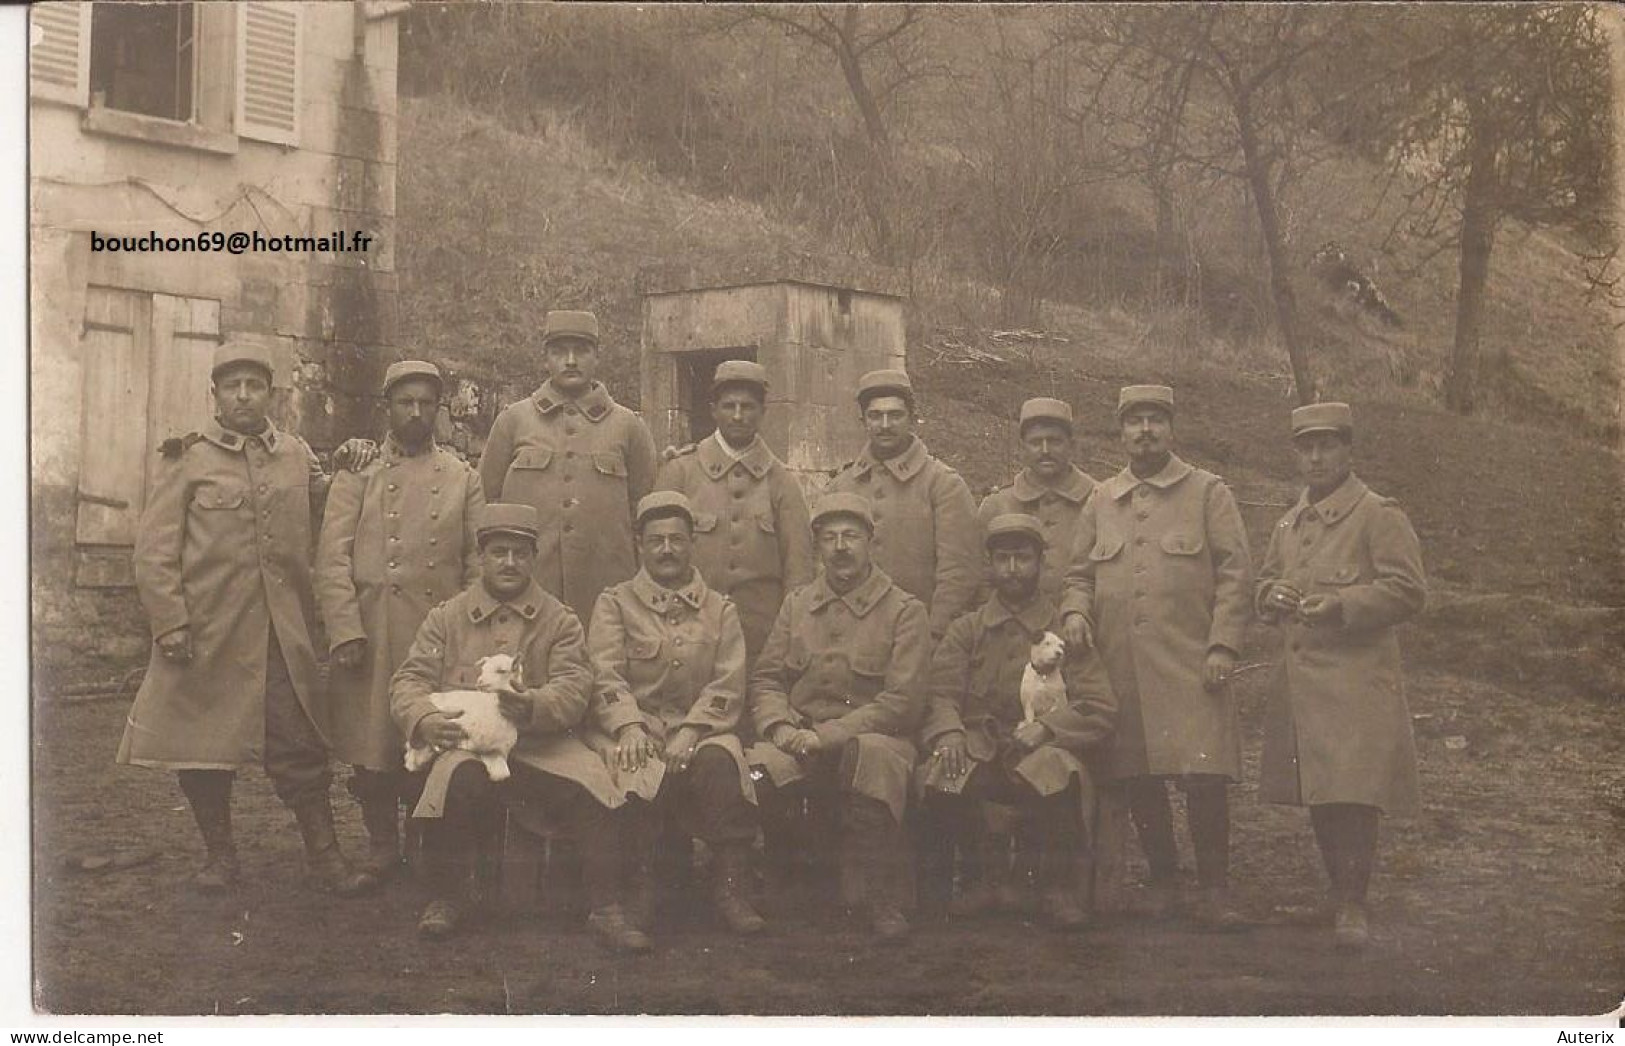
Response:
1344,3,1617,414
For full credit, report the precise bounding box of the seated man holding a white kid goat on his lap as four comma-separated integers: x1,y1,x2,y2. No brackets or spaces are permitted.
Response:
390,504,650,952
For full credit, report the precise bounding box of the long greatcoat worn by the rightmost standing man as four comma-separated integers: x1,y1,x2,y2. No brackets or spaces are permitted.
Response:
1258,474,1427,814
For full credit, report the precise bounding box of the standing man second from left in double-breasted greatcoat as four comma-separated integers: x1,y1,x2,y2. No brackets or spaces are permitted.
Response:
315,361,484,877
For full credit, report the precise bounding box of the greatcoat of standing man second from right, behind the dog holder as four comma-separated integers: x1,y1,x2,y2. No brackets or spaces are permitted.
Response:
1061,456,1253,780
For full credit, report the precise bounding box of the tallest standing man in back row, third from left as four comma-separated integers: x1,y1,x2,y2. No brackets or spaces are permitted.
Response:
479,312,657,617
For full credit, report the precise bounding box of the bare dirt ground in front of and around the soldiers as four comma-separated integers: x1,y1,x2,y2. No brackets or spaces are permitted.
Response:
34,662,1625,1015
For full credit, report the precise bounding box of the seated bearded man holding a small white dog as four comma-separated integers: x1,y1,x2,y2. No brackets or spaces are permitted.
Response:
920,513,1116,929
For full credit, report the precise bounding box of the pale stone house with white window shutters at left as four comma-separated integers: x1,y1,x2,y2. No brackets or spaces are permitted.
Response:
29,0,406,689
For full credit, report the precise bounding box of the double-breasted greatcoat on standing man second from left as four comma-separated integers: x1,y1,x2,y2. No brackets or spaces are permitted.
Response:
315,437,484,770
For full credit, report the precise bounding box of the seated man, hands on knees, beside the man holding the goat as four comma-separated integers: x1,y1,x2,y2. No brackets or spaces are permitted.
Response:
588,491,764,934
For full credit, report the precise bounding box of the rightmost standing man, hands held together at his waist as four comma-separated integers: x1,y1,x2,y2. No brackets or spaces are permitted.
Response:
1256,403,1427,949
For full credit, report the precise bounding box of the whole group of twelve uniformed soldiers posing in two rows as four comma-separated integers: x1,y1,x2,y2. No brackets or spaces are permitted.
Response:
119,312,1425,952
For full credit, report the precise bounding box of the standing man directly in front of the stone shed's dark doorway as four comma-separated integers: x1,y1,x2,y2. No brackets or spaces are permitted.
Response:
655,359,813,661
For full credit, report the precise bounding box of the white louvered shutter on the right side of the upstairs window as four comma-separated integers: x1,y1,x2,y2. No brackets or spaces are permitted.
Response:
237,3,301,145
